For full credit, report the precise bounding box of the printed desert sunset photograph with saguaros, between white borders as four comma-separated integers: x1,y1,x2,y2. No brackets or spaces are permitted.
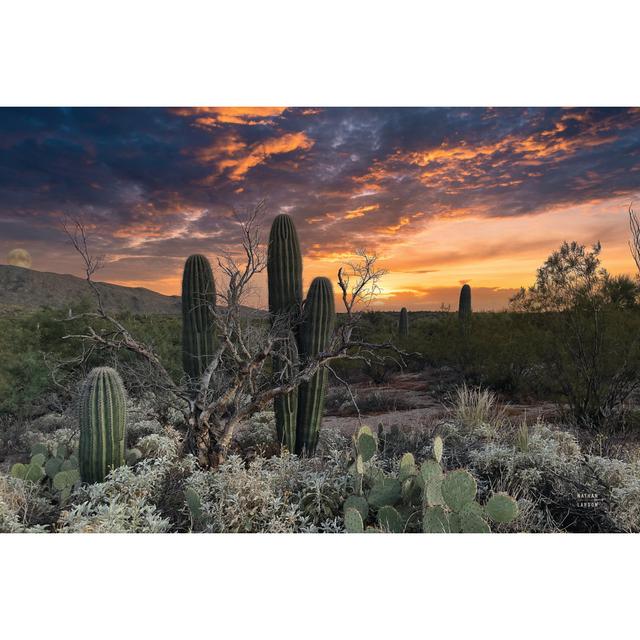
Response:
0,106,640,535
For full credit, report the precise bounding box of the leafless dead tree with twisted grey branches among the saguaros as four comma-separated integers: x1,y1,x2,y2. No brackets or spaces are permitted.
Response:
65,203,409,468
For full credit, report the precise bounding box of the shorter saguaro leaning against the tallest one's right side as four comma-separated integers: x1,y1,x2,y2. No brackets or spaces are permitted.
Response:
295,278,336,455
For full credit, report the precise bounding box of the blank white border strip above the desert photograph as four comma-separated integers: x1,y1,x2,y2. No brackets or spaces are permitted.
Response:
0,0,640,106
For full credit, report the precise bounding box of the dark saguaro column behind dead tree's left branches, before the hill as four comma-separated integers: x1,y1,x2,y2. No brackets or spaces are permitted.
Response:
182,254,216,383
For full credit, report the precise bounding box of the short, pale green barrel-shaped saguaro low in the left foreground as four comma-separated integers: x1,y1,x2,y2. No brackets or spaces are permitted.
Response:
78,367,127,482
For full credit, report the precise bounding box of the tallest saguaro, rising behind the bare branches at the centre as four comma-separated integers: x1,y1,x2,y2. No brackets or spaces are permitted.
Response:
267,214,302,451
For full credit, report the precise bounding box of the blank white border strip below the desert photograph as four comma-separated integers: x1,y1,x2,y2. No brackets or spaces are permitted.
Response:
0,534,640,640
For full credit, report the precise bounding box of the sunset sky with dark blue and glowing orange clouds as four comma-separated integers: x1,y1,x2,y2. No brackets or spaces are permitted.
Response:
0,107,640,310
